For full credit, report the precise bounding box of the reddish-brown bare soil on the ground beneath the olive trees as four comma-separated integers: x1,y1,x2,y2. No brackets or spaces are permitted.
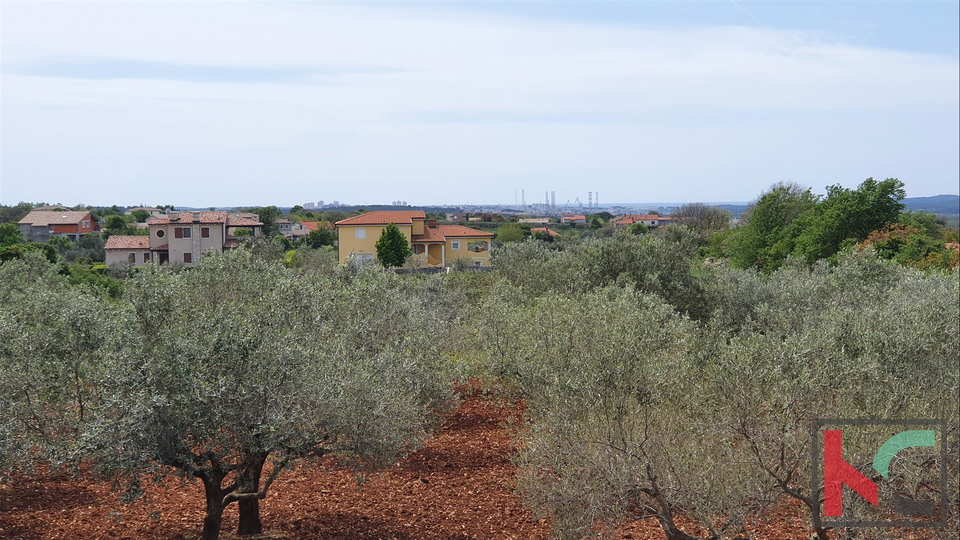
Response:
0,388,824,540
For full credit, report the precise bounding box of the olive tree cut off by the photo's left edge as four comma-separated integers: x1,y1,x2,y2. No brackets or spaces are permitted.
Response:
0,254,118,469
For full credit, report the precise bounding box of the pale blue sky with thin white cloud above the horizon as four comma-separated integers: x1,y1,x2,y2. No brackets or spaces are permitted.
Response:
0,0,960,207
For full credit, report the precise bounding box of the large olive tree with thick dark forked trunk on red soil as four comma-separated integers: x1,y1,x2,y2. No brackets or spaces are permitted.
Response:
86,250,450,540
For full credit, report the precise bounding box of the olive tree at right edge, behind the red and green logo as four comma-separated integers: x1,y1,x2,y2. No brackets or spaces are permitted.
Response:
700,253,960,539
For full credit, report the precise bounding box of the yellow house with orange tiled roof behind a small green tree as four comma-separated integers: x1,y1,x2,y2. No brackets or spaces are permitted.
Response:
336,210,493,267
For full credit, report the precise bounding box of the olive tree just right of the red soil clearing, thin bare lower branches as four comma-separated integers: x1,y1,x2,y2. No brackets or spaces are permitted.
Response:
479,286,761,540
